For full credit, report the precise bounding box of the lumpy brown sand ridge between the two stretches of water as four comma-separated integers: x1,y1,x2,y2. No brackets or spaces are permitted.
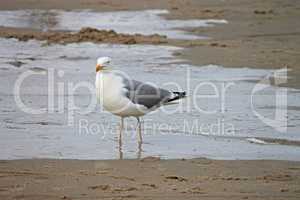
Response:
0,27,167,45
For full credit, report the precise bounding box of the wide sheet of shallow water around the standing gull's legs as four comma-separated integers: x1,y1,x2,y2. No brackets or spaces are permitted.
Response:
0,11,300,160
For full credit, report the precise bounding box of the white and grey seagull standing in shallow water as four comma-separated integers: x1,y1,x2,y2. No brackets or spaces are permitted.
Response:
95,57,186,144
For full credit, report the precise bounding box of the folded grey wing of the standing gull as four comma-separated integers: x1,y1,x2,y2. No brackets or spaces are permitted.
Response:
123,79,172,109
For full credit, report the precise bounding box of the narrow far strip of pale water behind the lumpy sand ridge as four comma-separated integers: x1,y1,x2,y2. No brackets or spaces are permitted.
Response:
0,10,227,39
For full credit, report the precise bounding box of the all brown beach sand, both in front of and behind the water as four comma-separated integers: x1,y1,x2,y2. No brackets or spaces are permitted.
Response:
0,0,300,200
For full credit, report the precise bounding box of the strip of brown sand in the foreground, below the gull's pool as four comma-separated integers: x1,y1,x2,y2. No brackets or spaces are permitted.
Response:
0,157,300,200
